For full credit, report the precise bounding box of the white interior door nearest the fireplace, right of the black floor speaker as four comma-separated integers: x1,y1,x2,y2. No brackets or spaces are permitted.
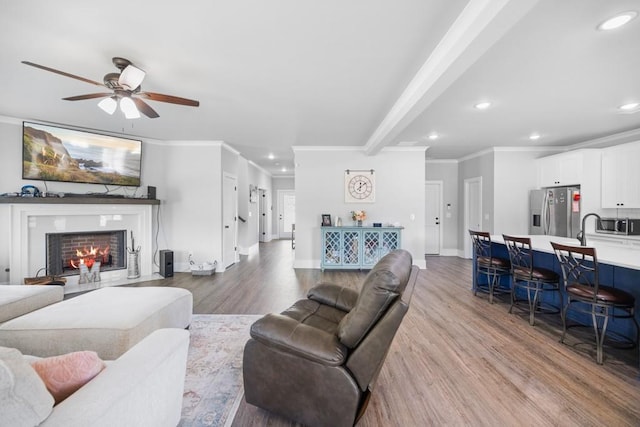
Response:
222,174,238,269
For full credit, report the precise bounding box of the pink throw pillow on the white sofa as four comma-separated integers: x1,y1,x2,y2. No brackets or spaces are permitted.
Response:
31,351,106,405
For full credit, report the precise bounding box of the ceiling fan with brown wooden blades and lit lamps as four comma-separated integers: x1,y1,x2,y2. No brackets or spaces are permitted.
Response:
22,57,200,119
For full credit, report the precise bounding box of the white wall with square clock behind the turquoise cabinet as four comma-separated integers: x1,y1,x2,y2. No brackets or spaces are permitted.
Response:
294,147,425,268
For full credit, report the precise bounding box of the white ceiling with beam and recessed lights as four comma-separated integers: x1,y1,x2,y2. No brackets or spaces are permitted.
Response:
0,0,640,176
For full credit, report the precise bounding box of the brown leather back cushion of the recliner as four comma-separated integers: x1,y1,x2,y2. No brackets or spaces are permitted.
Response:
338,249,413,348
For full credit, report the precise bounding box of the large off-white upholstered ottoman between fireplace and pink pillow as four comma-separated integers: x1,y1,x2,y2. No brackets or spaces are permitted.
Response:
0,286,193,360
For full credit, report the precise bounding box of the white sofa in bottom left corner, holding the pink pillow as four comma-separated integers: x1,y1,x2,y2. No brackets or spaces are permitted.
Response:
0,328,189,427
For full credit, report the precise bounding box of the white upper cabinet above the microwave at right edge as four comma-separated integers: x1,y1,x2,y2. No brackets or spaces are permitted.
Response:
602,142,640,209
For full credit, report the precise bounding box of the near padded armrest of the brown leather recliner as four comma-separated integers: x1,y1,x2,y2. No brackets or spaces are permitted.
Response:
251,313,347,366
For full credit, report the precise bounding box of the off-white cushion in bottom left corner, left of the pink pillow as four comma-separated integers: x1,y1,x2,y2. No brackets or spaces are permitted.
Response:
0,347,53,427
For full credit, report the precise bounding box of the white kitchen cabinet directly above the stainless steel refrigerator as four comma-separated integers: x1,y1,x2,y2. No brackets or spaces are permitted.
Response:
536,151,584,187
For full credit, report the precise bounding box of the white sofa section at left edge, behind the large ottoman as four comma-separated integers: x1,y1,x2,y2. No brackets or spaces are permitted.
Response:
0,285,64,323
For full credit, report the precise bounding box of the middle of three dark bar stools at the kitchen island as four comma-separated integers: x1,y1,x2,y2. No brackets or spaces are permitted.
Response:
502,234,562,326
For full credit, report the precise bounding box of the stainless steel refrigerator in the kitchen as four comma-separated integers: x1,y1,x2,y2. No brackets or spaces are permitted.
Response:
529,187,580,237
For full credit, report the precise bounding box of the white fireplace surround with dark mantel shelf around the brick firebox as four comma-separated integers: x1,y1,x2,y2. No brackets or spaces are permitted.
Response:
0,197,160,293
